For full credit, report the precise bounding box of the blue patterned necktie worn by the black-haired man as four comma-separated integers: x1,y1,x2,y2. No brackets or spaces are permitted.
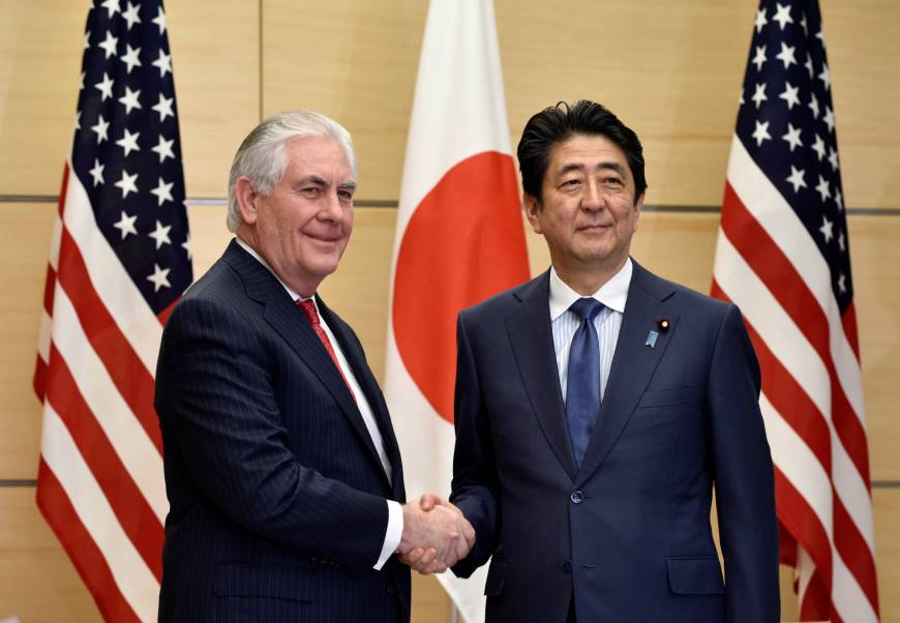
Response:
566,298,603,466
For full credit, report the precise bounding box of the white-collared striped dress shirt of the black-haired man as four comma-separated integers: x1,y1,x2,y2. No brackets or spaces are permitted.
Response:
550,257,634,404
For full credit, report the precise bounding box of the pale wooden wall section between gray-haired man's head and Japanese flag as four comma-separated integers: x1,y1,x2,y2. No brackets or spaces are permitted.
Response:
263,0,427,200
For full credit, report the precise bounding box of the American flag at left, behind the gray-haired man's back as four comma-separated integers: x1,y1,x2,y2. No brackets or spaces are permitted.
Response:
34,0,192,621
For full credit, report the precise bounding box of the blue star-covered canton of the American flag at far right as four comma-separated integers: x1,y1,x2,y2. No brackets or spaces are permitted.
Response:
737,0,853,314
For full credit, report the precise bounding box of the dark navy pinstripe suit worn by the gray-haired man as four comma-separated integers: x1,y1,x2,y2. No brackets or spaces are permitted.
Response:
156,241,410,623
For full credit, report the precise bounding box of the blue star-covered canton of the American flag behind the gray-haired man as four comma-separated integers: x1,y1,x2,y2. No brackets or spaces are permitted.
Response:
70,0,193,314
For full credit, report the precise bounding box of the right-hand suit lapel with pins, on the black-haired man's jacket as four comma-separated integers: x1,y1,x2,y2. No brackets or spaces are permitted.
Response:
576,262,678,485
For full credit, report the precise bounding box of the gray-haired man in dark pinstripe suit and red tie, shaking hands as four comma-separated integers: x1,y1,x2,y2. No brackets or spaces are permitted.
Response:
155,111,474,622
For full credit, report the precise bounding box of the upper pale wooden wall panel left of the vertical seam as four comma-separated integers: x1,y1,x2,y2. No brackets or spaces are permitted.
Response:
0,0,259,197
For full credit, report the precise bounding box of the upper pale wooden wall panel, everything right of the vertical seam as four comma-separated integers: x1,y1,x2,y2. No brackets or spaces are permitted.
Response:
263,0,900,207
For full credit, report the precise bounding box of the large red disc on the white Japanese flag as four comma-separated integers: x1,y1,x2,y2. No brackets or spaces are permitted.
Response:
393,152,529,422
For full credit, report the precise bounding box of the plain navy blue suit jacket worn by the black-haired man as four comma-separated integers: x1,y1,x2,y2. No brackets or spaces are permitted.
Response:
451,263,780,623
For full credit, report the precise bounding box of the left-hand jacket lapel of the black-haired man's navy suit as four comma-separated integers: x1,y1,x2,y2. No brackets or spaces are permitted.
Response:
506,272,577,480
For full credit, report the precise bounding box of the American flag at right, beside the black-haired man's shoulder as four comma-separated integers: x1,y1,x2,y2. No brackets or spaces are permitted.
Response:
713,0,878,623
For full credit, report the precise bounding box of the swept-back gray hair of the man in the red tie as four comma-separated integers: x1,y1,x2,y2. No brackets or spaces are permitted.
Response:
225,110,356,233
